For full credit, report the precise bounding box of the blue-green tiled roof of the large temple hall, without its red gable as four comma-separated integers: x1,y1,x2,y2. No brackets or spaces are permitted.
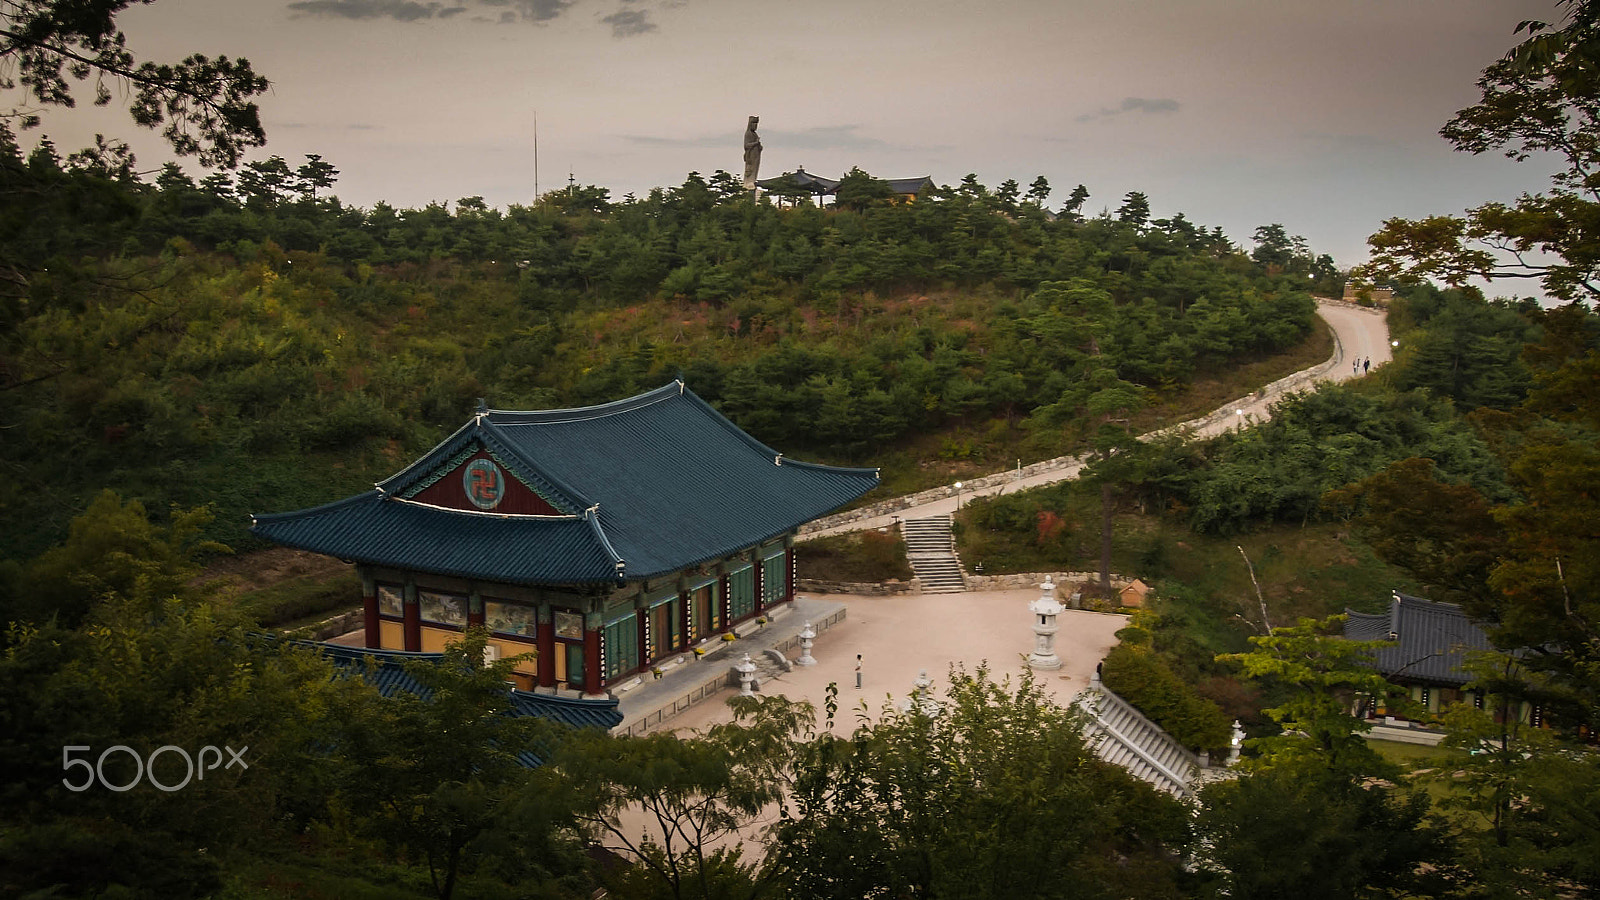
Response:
251,381,878,585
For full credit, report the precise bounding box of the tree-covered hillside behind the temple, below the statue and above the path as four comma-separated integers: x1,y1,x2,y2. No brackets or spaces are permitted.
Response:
0,129,1333,557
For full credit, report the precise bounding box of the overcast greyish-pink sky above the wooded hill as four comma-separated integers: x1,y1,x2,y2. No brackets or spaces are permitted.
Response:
24,0,1558,266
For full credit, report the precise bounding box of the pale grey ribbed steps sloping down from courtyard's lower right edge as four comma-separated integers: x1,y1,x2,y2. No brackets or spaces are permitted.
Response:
1074,677,1200,798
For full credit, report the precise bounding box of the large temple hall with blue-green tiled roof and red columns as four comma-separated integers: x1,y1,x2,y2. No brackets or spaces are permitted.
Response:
250,381,878,695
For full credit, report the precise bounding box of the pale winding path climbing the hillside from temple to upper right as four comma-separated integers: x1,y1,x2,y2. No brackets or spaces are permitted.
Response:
798,299,1392,540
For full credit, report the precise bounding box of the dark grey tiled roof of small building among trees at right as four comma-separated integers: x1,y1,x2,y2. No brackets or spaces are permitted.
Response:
1344,591,1493,687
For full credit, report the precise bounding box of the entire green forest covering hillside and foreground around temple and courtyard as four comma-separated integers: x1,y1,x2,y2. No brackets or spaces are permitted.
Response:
0,0,1600,900
